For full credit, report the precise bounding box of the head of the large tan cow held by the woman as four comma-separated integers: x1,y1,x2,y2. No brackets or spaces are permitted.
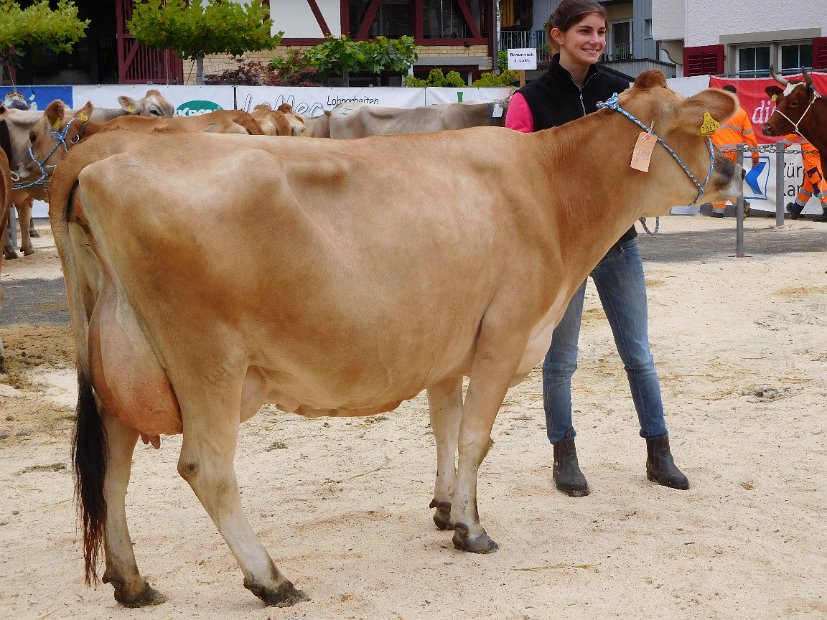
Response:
619,70,744,216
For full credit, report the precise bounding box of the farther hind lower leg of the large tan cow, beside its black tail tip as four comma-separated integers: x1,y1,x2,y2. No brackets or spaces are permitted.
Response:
101,412,166,607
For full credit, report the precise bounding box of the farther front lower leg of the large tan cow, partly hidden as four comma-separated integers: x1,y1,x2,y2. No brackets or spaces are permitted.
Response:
428,377,462,530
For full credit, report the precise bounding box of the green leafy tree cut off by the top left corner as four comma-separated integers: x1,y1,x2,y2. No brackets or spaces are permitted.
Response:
0,0,89,79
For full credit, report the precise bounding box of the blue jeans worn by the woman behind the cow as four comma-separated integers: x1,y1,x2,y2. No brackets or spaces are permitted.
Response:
543,239,667,444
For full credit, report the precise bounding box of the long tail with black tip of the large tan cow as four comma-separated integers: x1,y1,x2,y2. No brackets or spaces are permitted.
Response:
49,167,108,585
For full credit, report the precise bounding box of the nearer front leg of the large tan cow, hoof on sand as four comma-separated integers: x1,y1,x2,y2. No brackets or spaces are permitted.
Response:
451,327,525,553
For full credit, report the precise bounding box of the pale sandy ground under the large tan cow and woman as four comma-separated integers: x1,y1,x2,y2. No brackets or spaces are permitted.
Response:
0,216,827,620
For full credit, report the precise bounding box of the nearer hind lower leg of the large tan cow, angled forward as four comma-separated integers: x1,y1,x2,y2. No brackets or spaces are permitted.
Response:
178,406,307,607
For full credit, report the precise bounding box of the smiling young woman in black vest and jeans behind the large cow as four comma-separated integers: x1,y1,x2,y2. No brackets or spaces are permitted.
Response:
506,0,689,496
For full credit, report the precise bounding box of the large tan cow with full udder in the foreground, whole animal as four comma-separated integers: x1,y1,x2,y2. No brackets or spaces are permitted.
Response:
50,72,743,606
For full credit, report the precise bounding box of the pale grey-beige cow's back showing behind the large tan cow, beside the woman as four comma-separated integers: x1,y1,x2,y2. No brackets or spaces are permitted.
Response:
328,101,507,140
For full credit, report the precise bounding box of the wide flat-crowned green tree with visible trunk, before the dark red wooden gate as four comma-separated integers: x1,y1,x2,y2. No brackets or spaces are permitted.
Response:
127,0,284,84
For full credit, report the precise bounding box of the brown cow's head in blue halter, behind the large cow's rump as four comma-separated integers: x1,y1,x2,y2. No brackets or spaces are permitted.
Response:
21,99,92,181
